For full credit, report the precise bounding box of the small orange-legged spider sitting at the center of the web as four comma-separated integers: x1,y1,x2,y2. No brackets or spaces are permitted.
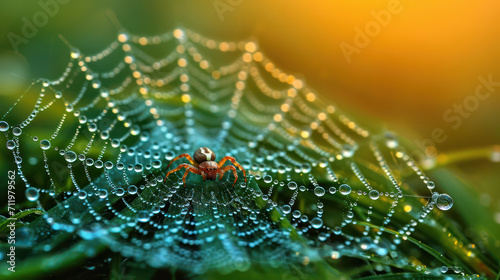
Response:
165,147,247,187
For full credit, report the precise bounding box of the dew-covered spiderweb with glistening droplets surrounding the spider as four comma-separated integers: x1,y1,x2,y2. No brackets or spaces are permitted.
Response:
0,29,464,275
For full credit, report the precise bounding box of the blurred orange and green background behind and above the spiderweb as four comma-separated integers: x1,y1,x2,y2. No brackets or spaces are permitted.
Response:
0,0,500,238
